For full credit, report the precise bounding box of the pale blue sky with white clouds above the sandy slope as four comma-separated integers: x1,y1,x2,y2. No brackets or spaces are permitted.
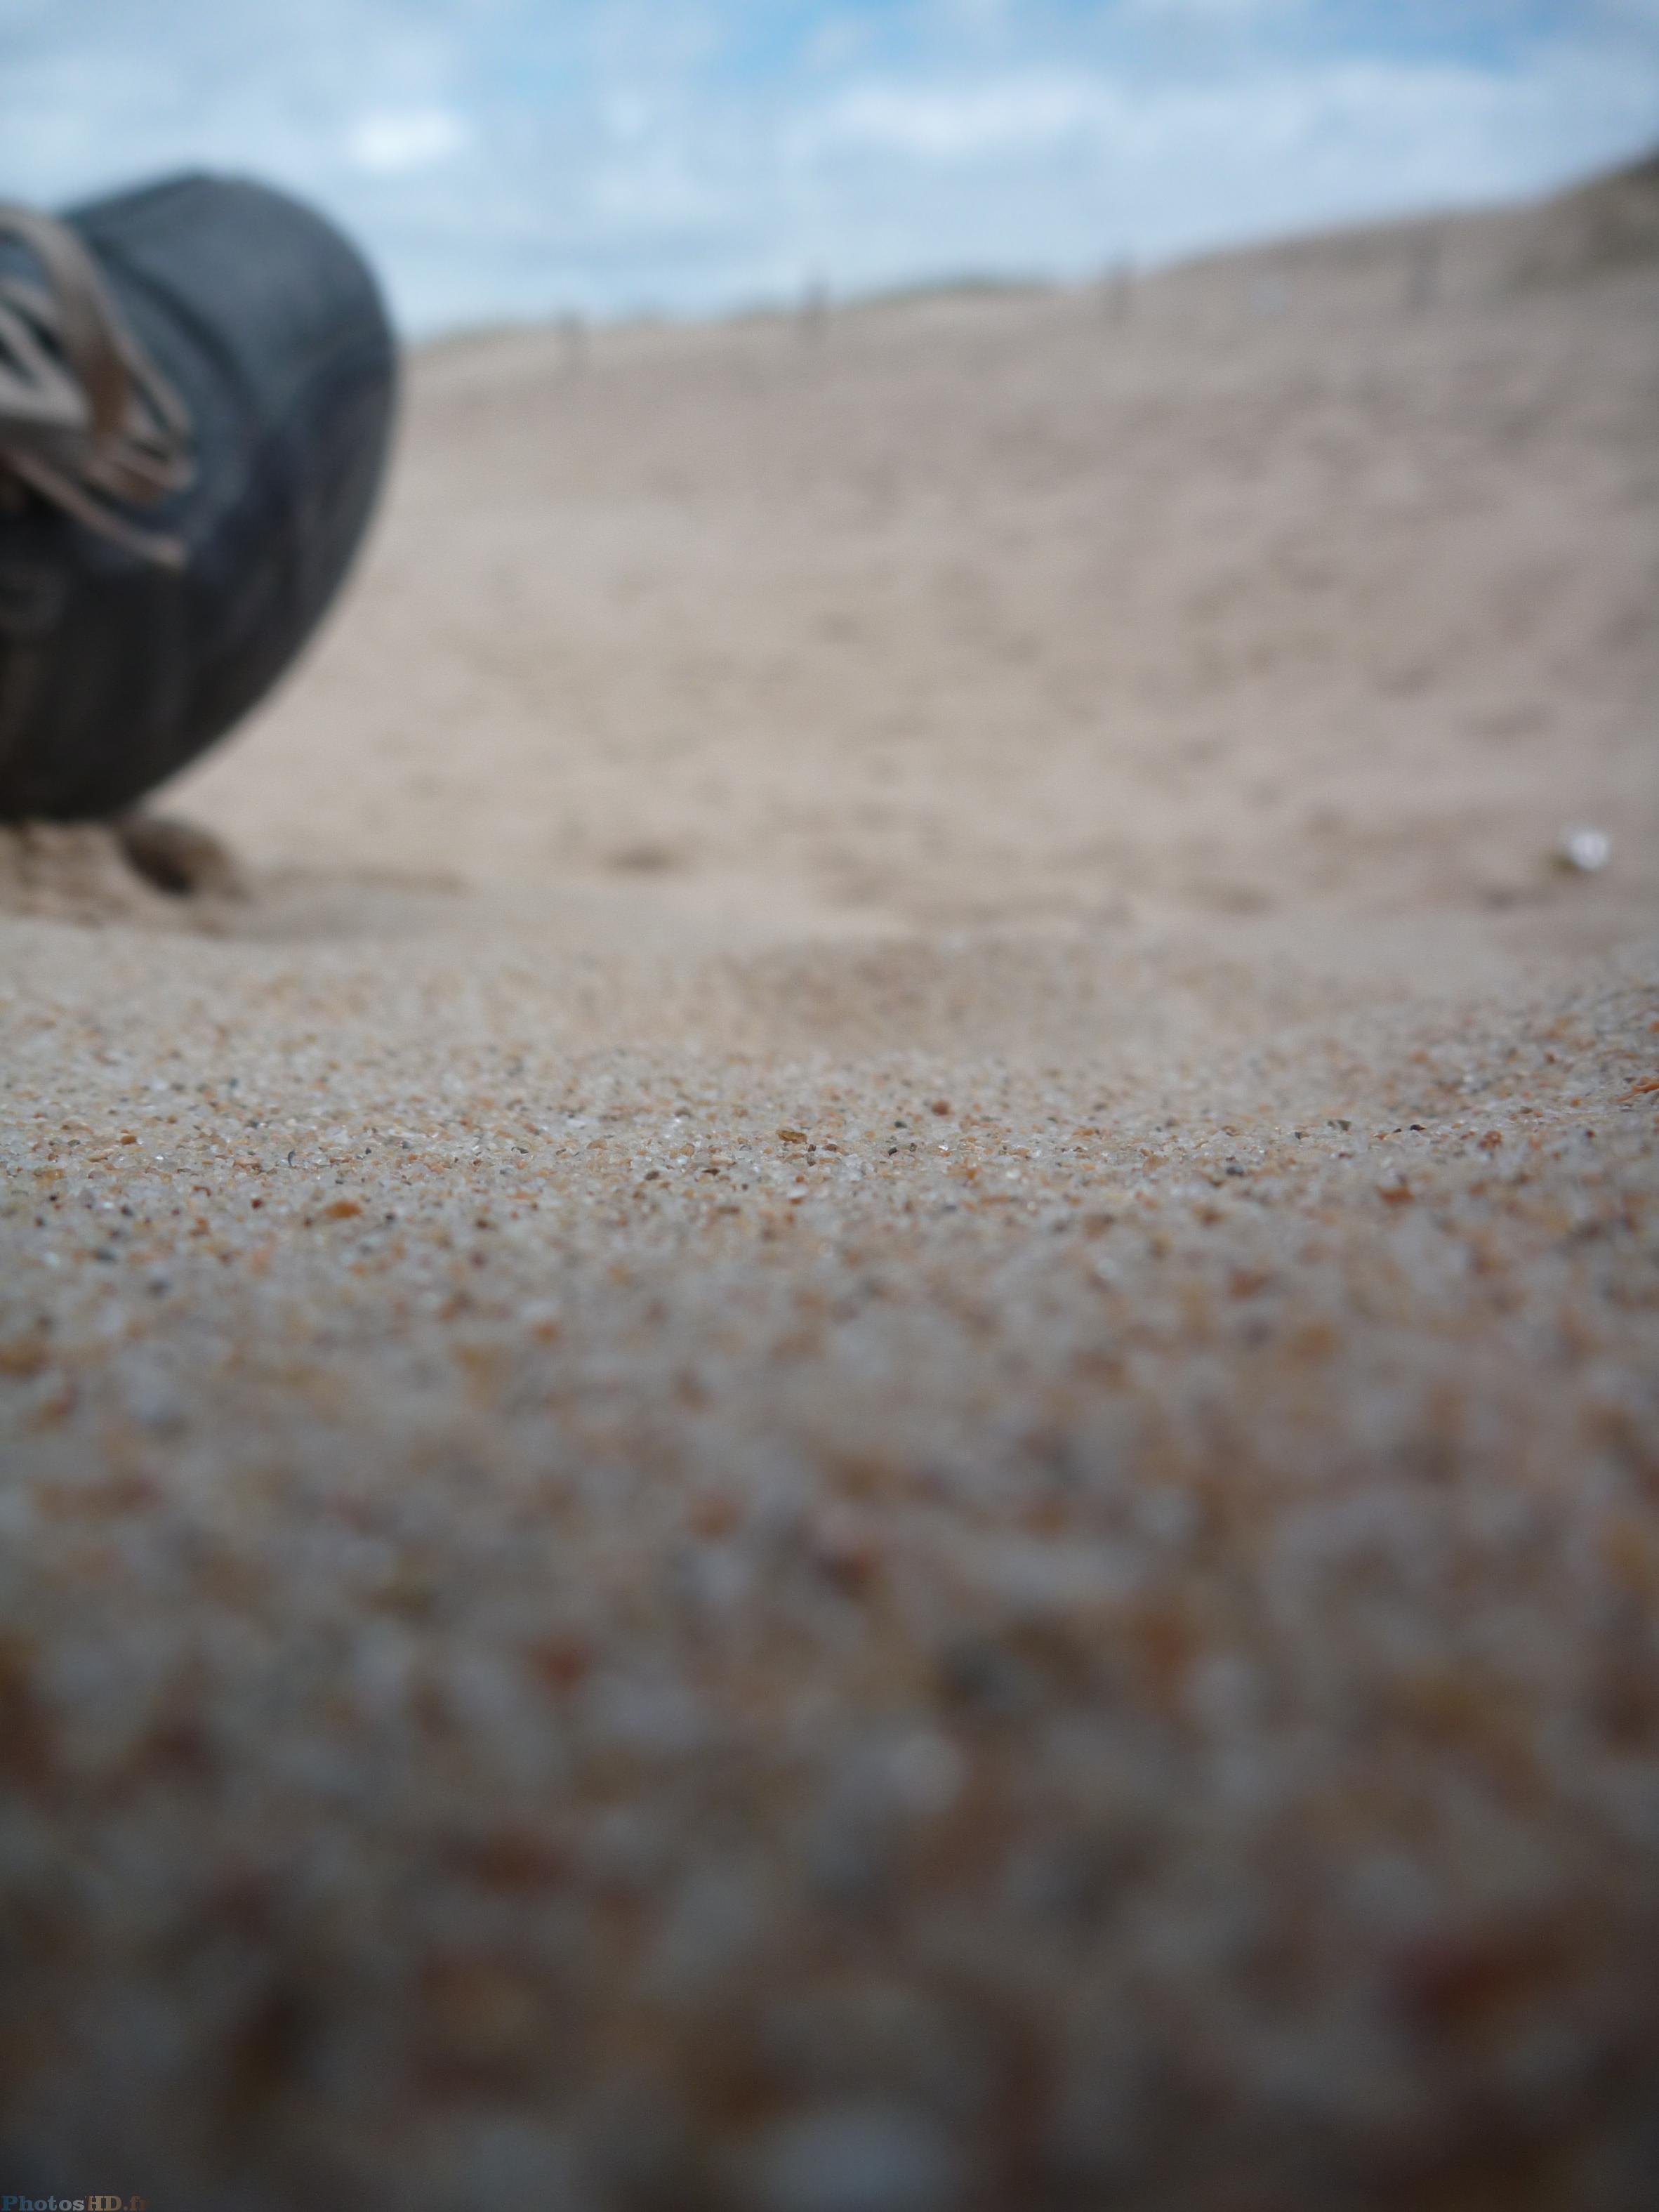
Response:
0,0,1659,334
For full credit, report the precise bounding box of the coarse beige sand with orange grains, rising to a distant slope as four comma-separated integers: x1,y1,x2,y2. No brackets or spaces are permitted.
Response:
0,168,1659,2212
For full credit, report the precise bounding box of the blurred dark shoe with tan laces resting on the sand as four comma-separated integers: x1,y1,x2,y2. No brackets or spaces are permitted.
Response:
0,177,396,821
